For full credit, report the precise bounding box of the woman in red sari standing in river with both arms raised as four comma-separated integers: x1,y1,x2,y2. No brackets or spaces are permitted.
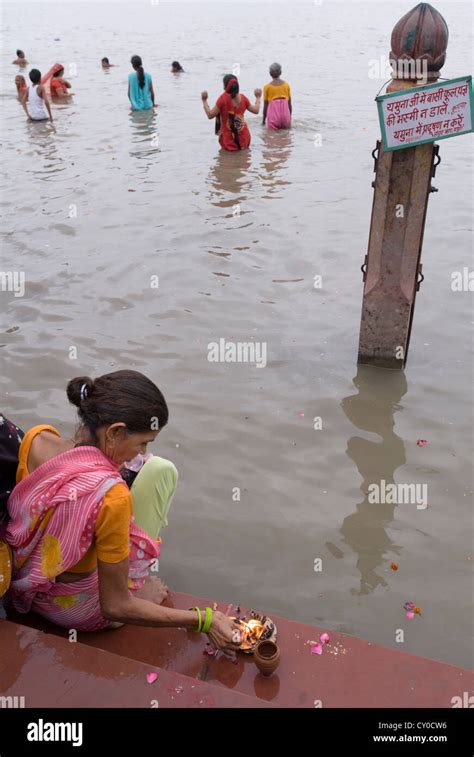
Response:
201,76,262,152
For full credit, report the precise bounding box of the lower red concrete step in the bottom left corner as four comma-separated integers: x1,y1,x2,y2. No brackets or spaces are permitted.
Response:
0,620,271,709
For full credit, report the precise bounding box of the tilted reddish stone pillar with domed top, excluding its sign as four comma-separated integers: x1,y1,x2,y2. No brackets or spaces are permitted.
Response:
358,3,448,368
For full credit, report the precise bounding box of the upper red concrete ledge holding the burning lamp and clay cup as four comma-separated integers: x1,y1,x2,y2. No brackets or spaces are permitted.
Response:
2,593,474,708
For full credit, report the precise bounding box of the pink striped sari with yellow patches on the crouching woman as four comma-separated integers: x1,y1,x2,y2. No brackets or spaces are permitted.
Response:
6,447,160,631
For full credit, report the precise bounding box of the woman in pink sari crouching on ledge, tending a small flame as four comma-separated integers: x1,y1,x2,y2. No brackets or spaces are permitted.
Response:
6,370,240,653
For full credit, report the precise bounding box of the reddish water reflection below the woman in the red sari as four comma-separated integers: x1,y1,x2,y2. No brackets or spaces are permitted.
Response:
209,150,252,208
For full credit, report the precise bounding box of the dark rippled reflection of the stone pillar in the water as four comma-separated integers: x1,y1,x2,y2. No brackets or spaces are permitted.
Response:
340,367,407,594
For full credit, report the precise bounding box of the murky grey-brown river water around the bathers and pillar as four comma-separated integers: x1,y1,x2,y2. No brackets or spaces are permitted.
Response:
0,2,474,665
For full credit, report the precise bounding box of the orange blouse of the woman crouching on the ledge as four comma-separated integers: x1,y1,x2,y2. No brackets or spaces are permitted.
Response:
16,425,132,573
